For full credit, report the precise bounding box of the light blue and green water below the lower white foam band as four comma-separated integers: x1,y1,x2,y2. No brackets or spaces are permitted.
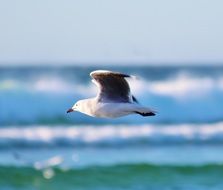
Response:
0,145,223,189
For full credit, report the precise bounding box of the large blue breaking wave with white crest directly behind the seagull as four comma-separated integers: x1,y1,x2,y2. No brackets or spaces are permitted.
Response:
0,69,223,126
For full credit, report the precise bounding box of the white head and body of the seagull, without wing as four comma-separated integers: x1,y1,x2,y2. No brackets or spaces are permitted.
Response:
72,98,152,118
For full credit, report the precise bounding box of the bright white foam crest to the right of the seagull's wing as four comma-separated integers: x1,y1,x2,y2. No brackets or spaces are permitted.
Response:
131,73,223,98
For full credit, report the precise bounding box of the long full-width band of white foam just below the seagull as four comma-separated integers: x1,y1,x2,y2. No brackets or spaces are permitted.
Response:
0,123,223,147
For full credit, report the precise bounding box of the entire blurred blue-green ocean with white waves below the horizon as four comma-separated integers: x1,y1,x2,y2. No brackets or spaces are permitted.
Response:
0,66,223,190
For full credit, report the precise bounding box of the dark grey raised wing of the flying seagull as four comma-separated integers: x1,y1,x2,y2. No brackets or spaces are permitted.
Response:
90,70,133,102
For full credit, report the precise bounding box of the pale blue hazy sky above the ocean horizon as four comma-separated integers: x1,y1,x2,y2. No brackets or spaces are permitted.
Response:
0,0,223,64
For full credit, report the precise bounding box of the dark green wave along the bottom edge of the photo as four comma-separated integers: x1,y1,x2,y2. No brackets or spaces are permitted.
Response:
0,164,223,190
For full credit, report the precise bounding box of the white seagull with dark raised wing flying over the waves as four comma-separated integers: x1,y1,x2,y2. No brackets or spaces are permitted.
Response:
67,70,156,118
